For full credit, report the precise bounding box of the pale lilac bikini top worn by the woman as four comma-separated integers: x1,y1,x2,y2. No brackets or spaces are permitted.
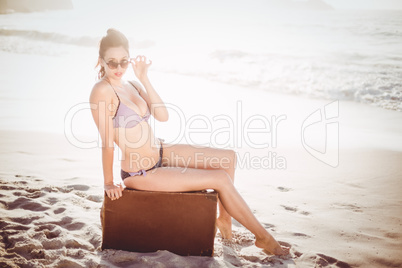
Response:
109,81,151,128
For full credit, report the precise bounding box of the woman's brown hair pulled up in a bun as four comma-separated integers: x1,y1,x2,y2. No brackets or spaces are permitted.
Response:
95,28,129,79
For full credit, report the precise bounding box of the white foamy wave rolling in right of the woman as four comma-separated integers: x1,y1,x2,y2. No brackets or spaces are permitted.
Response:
157,50,402,111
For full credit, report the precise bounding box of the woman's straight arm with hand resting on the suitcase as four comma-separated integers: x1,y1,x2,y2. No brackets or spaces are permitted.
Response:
89,83,123,200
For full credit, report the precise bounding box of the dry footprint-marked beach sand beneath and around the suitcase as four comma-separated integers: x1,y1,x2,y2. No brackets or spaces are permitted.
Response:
0,131,402,267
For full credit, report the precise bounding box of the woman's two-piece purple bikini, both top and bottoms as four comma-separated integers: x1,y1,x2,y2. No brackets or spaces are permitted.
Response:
108,81,164,181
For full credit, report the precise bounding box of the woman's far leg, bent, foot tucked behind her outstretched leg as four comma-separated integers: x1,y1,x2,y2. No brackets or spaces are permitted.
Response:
163,143,236,239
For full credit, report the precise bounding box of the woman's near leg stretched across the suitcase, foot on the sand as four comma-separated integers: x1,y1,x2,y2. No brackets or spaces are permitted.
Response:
124,167,289,255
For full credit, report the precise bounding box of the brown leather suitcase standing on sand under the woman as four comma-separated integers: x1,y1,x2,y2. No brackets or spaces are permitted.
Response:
101,189,218,256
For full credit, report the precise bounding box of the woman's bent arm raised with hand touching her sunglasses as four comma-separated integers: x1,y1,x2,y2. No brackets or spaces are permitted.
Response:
132,56,169,122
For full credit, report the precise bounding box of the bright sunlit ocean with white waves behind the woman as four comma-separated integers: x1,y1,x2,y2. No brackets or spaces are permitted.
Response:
0,0,402,136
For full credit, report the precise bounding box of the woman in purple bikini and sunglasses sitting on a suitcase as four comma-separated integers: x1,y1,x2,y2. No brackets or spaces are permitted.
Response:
90,29,289,255
